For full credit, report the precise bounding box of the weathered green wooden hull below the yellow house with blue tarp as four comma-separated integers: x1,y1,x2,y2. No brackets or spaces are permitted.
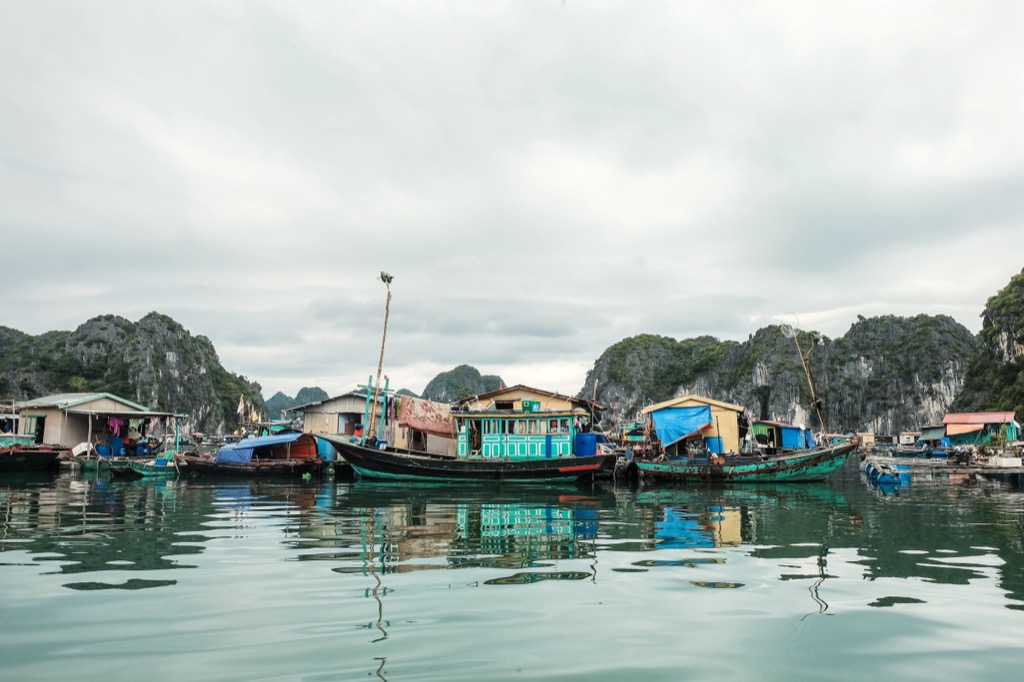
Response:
636,439,858,483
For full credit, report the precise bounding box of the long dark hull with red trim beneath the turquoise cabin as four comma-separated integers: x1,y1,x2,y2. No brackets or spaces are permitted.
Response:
318,434,614,481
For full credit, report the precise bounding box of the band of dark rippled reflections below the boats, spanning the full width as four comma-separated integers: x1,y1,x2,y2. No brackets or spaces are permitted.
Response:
0,474,1024,606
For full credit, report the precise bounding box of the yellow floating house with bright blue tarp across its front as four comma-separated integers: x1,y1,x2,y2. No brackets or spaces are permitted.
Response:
643,395,745,455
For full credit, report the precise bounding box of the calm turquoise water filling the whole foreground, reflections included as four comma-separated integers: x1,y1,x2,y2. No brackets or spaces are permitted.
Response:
0,462,1024,682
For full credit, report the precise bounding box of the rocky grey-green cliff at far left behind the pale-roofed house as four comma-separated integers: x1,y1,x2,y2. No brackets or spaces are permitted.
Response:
0,312,263,432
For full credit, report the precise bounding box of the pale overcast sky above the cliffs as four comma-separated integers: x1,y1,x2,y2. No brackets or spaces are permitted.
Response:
0,0,1024,397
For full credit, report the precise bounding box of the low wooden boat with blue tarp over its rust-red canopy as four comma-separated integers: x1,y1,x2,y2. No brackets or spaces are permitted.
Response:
181,432,324,476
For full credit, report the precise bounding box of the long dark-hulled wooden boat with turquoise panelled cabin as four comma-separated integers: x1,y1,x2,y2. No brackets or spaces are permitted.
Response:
316,411,615,482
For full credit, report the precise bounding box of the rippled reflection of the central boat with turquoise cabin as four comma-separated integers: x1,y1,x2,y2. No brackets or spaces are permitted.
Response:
296,484,598,580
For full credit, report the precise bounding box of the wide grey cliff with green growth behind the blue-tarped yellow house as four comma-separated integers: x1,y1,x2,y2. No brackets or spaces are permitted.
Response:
582,315,977,434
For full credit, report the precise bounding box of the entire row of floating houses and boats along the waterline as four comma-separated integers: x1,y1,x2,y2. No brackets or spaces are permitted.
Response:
0,378,1024,486
